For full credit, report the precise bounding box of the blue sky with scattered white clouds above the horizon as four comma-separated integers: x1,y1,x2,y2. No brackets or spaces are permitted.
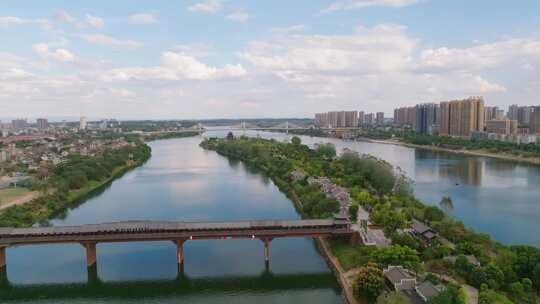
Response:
0,0,540,119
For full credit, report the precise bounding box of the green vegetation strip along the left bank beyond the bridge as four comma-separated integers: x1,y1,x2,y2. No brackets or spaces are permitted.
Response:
0,142,151,227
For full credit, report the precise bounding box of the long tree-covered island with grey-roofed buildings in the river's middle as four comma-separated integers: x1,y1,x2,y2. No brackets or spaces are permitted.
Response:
201,135,540,304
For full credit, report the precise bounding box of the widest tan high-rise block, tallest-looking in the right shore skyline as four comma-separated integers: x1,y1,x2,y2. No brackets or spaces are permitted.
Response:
439,97,485,137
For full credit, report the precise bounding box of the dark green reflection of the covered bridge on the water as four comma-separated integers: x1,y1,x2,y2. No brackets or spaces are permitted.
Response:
0,268,339,301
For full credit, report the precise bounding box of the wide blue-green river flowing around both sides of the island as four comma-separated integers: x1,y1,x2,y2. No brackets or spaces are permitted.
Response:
0,131,540,304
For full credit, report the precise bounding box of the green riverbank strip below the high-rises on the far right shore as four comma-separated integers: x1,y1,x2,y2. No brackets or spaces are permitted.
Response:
358,137,540,165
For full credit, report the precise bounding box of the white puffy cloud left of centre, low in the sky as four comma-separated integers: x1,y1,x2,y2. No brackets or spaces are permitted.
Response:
101,52,247,81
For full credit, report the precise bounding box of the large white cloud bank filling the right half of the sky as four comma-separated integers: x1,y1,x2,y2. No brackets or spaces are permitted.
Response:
240,24,540,113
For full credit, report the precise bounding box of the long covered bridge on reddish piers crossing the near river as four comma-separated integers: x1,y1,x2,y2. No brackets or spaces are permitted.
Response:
0,217,356,270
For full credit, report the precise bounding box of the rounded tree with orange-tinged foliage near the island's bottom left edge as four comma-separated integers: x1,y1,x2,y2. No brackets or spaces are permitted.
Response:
354,262,384,301
